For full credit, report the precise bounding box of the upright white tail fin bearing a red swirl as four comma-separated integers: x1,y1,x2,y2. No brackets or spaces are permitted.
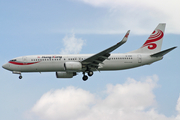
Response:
131,23,166,53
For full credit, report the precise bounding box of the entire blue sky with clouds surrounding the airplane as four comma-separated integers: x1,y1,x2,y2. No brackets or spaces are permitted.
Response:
0,0,180,120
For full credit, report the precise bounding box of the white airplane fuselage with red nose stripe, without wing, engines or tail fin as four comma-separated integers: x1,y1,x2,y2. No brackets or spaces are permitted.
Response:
3,53,162,72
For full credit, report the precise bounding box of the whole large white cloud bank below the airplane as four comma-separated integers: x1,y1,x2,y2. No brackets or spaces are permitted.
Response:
28,75,180,120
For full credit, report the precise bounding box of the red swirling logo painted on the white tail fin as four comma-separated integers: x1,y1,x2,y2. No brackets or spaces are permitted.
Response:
142,29,164,50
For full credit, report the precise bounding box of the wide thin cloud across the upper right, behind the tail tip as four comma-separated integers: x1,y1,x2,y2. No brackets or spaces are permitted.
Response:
77,0,180,34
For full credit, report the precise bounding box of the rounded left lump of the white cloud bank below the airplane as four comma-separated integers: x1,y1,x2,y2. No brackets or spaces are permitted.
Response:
32,87,94,120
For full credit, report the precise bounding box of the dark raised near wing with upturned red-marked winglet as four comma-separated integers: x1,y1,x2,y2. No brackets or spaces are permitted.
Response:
81,30,130,68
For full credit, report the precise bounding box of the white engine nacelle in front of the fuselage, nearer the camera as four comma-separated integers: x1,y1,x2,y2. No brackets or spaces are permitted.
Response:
64,62,82,72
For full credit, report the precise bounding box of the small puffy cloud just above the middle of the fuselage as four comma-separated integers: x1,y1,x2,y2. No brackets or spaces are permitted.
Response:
61,33,85,54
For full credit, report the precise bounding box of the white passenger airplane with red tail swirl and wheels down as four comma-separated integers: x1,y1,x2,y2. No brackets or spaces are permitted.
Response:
2,23,176,81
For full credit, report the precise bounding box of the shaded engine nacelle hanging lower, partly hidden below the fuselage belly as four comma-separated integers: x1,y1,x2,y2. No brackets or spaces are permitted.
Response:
56,72,76,78
